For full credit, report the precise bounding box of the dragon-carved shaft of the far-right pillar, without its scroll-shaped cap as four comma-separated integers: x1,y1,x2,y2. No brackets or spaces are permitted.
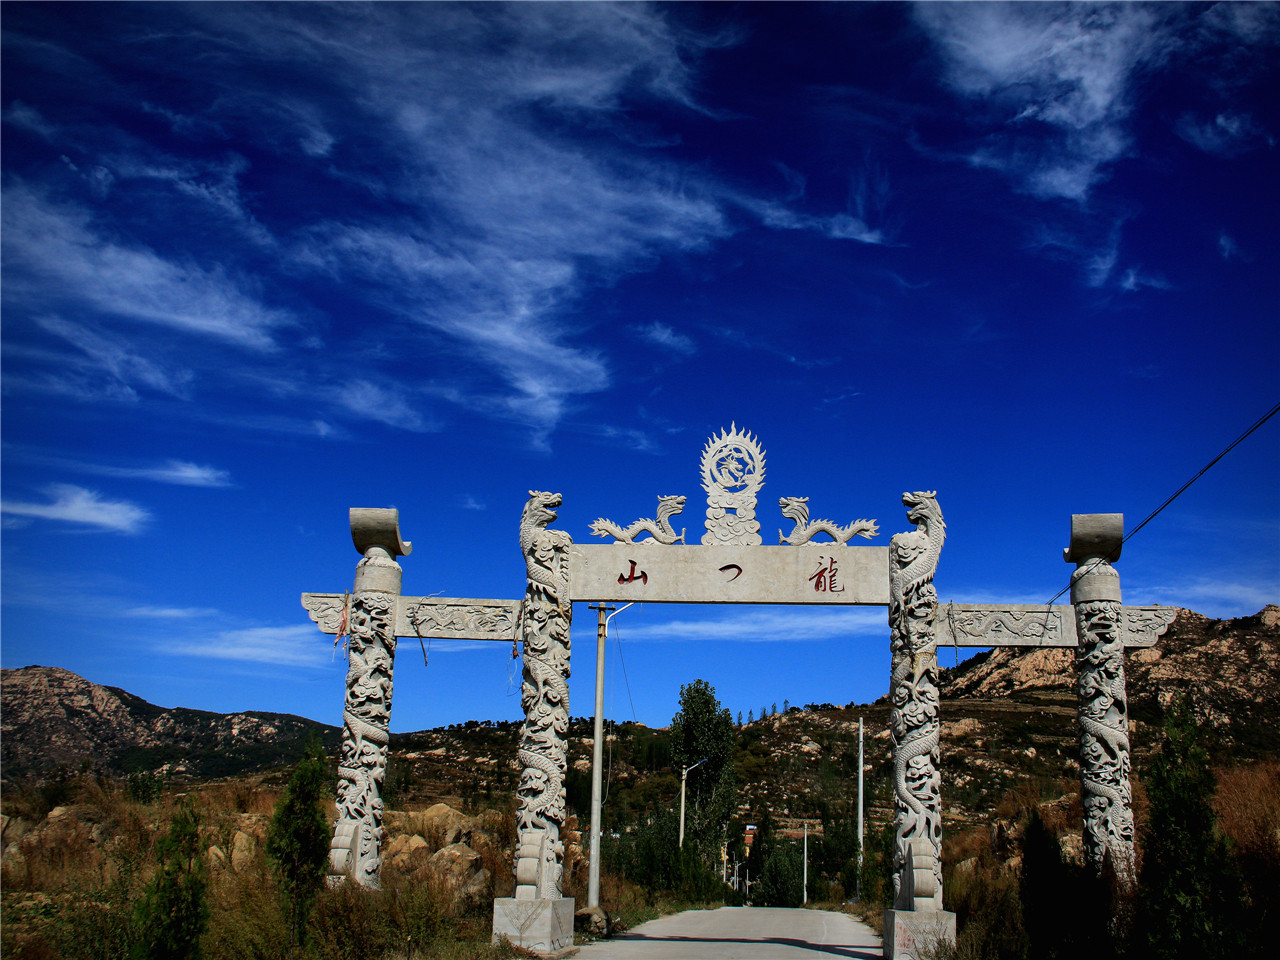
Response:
1075,576,1134,884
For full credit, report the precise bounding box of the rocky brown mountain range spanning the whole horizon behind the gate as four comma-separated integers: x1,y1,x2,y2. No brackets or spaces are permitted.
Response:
3,607,1280,829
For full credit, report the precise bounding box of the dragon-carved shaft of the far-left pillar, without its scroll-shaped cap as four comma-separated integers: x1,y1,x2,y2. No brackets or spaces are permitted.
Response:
329,570,396,887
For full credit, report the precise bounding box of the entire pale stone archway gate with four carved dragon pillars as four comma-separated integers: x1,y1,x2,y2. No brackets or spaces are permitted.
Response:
302,425,1176,957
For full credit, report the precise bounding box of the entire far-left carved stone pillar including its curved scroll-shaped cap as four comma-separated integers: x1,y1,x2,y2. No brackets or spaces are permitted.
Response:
329,507,412,887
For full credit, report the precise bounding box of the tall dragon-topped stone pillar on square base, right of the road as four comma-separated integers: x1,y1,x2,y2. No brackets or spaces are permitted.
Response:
884,492,956,957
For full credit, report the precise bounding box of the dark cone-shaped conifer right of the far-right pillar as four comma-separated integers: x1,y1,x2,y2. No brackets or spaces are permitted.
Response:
1137,698,1245,960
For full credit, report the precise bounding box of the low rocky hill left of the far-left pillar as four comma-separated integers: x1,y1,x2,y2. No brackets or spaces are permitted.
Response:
0,667,339,786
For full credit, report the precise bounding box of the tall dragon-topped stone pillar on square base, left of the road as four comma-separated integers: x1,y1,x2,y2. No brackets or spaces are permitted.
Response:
493,490,573,955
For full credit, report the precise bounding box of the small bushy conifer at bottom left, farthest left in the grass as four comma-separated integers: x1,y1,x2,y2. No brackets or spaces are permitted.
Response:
131,799,209,960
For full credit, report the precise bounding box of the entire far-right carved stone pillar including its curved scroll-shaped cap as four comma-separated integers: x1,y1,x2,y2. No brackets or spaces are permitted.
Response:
1062,513,1134,886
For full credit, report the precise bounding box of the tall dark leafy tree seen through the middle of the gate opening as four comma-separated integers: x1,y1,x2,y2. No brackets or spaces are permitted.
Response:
671,680,736,855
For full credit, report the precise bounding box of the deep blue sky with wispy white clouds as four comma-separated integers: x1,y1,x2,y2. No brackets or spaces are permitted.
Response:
0,3,1280,731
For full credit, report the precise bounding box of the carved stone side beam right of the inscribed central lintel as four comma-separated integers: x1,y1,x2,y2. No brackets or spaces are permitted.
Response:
936,603,1178,648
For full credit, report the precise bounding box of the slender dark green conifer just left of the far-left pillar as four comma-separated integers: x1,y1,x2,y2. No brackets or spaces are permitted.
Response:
266,739,329,946
